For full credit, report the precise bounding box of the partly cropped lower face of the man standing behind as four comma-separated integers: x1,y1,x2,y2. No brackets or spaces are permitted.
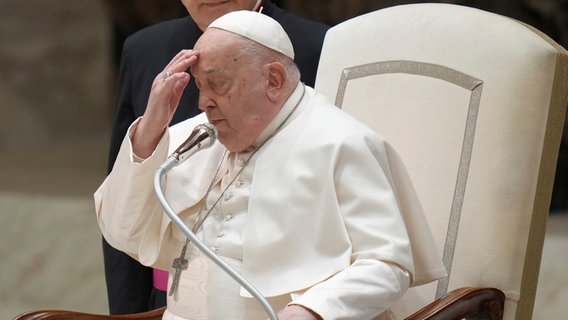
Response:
181,0,256,30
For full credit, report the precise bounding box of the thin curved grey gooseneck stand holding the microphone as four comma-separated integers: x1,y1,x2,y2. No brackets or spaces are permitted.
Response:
154,156,278,320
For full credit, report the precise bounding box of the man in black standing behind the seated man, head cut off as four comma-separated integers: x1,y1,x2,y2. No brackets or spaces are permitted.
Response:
103,0,329,314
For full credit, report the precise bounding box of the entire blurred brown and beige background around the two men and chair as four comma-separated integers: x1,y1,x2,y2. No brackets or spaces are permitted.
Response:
0,0,568,319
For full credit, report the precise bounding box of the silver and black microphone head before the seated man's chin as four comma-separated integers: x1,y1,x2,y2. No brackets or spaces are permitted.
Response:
170,123,217,166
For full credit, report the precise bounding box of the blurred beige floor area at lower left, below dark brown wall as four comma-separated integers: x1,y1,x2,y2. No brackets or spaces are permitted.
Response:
0,141,107,319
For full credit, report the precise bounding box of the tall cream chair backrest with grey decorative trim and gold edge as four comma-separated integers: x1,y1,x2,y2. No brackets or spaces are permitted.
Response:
315,3,568,319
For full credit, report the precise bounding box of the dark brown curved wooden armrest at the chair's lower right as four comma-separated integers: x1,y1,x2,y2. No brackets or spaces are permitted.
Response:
405,288,505,320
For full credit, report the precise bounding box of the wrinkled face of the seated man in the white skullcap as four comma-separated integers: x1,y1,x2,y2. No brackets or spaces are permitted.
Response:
191,28,274,152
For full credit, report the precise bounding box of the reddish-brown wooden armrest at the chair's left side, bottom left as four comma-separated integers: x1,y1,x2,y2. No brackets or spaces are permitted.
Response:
14,307,166,320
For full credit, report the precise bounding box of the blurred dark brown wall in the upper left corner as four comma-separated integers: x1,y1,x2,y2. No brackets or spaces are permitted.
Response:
0,0,111,152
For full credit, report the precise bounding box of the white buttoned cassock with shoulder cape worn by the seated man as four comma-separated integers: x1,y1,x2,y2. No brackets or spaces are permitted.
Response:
95,84,445,320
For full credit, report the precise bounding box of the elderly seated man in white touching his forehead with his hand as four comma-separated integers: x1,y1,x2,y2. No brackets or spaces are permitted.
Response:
95,11,443,320
